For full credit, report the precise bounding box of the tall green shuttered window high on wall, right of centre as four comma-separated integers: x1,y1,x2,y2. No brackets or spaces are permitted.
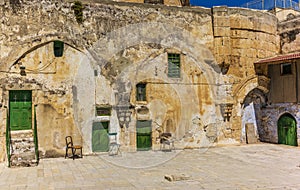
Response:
168,53,180,78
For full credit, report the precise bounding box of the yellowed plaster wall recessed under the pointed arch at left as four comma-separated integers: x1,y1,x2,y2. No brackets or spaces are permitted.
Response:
1,36,95,153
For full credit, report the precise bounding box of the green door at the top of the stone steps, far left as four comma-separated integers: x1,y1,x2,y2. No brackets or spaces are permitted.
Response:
9,90,32,130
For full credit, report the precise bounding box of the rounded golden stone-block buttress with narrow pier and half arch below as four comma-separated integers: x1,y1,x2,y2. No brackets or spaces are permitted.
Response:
213,7,280,140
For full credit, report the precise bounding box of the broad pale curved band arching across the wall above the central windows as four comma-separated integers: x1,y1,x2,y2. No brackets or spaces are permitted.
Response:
89,22,222,102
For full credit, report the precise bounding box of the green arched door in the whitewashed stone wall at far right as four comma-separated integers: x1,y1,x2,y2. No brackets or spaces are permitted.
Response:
277,113,298,146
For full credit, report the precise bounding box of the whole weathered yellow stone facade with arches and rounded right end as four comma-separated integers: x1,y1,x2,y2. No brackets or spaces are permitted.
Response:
0,0,280,165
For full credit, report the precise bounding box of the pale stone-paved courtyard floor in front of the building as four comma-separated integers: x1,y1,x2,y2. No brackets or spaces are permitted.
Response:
0,144,300,190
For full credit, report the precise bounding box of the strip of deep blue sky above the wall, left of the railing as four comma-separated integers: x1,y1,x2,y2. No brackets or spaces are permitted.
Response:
190,0,251,7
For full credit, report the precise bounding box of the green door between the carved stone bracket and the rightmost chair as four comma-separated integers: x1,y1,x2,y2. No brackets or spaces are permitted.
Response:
136,121,152,150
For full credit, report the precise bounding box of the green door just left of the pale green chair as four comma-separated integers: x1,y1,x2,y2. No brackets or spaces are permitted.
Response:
92,121,109,152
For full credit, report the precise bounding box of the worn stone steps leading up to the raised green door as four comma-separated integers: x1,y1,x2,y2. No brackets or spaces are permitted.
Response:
10,130,38,167
